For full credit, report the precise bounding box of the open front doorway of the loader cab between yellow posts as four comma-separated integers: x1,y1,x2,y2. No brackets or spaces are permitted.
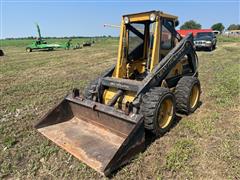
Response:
125,20,156,79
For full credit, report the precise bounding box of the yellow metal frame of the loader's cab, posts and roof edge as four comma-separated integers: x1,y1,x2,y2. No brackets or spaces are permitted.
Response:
113,11,177,78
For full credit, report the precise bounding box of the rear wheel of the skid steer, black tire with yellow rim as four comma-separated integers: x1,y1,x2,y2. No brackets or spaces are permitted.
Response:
175,76,201,115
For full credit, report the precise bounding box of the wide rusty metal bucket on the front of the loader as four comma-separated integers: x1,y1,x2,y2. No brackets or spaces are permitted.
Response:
35,95,145,176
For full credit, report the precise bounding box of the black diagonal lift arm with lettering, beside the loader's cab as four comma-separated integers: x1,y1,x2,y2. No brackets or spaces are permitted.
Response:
135,34,198,96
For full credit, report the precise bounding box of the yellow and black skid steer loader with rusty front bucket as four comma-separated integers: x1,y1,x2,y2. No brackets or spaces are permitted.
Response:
36,11,201,176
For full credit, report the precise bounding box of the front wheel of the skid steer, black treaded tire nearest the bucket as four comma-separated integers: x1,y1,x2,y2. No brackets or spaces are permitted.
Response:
140,87,176,136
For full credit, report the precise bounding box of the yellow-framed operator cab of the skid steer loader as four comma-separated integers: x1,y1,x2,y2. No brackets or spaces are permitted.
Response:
115,11,177,80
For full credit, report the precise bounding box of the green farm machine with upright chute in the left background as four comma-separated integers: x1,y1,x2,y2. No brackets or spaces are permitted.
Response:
26,24,71,52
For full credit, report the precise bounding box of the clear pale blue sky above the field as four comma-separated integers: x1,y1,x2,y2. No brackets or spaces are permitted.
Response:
0,0,240,39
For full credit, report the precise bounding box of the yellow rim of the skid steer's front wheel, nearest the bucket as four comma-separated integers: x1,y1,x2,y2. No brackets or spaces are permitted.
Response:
158,98,173,128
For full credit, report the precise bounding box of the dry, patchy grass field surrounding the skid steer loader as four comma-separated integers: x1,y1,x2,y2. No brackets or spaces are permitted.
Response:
0,36,240,180
